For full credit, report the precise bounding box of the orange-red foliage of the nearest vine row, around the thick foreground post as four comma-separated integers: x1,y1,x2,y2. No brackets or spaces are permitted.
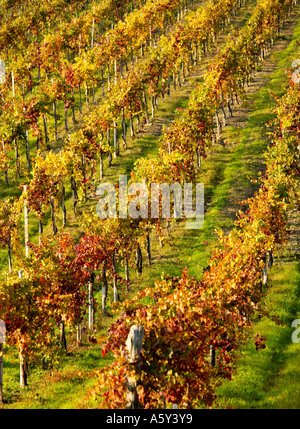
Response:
83,65,300,408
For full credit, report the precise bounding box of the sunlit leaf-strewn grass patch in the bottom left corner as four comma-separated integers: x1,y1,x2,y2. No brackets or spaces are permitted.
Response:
4,335,111,409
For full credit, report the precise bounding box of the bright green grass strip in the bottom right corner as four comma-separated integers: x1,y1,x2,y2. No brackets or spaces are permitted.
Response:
215,261,300,409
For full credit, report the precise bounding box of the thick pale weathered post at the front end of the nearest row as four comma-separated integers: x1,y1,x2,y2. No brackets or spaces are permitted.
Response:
126,325,144,409
